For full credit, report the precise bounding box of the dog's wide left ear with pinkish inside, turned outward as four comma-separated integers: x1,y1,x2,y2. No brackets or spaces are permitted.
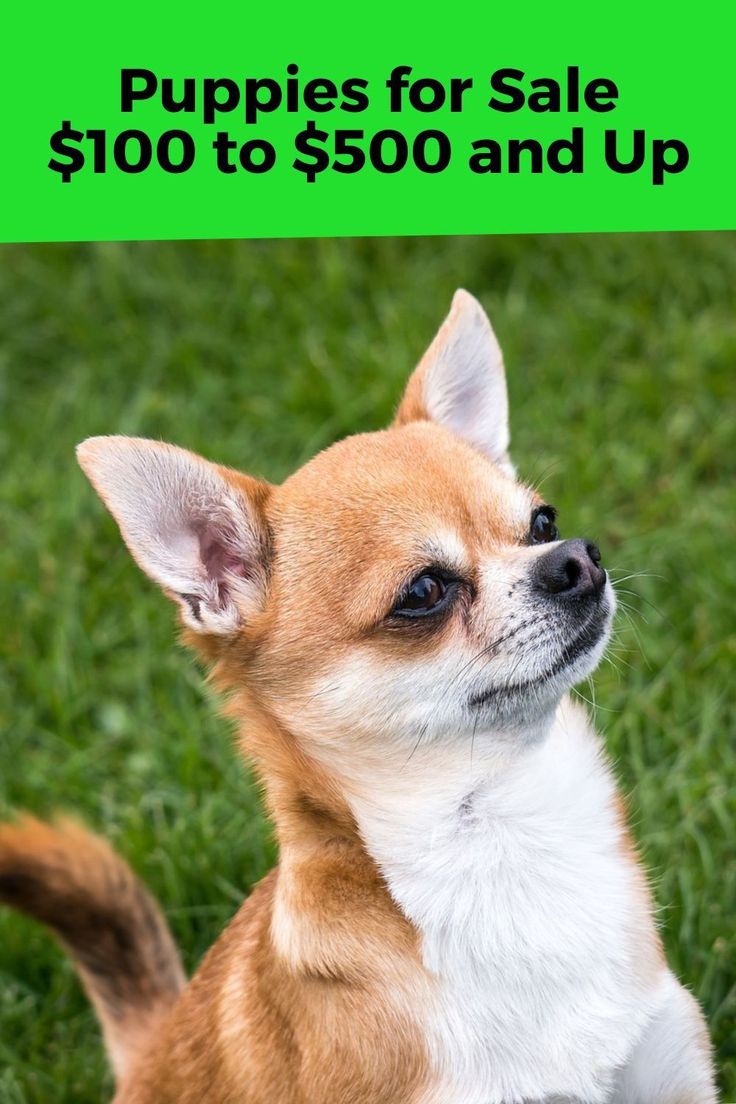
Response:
77,437,269,636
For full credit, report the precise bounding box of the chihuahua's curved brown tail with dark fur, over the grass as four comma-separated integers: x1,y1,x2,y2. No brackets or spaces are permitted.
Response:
0,816,184,1081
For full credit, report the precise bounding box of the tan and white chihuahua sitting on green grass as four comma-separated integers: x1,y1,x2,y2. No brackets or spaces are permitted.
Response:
0,291,716,1104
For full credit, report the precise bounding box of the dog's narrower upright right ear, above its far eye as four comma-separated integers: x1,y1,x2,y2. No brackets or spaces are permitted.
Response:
396,289,514,475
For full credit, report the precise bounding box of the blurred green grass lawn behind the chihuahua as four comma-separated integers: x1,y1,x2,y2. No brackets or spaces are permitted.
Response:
0,234,736,1104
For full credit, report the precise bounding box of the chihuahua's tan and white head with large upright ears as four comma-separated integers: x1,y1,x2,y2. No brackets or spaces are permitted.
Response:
78,291,614,768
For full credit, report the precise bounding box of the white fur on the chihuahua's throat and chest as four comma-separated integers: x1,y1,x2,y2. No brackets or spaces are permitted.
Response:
354,702,664,1104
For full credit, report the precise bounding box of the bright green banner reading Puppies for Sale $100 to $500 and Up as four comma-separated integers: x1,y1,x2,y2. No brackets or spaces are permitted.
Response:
0,0,736,241
